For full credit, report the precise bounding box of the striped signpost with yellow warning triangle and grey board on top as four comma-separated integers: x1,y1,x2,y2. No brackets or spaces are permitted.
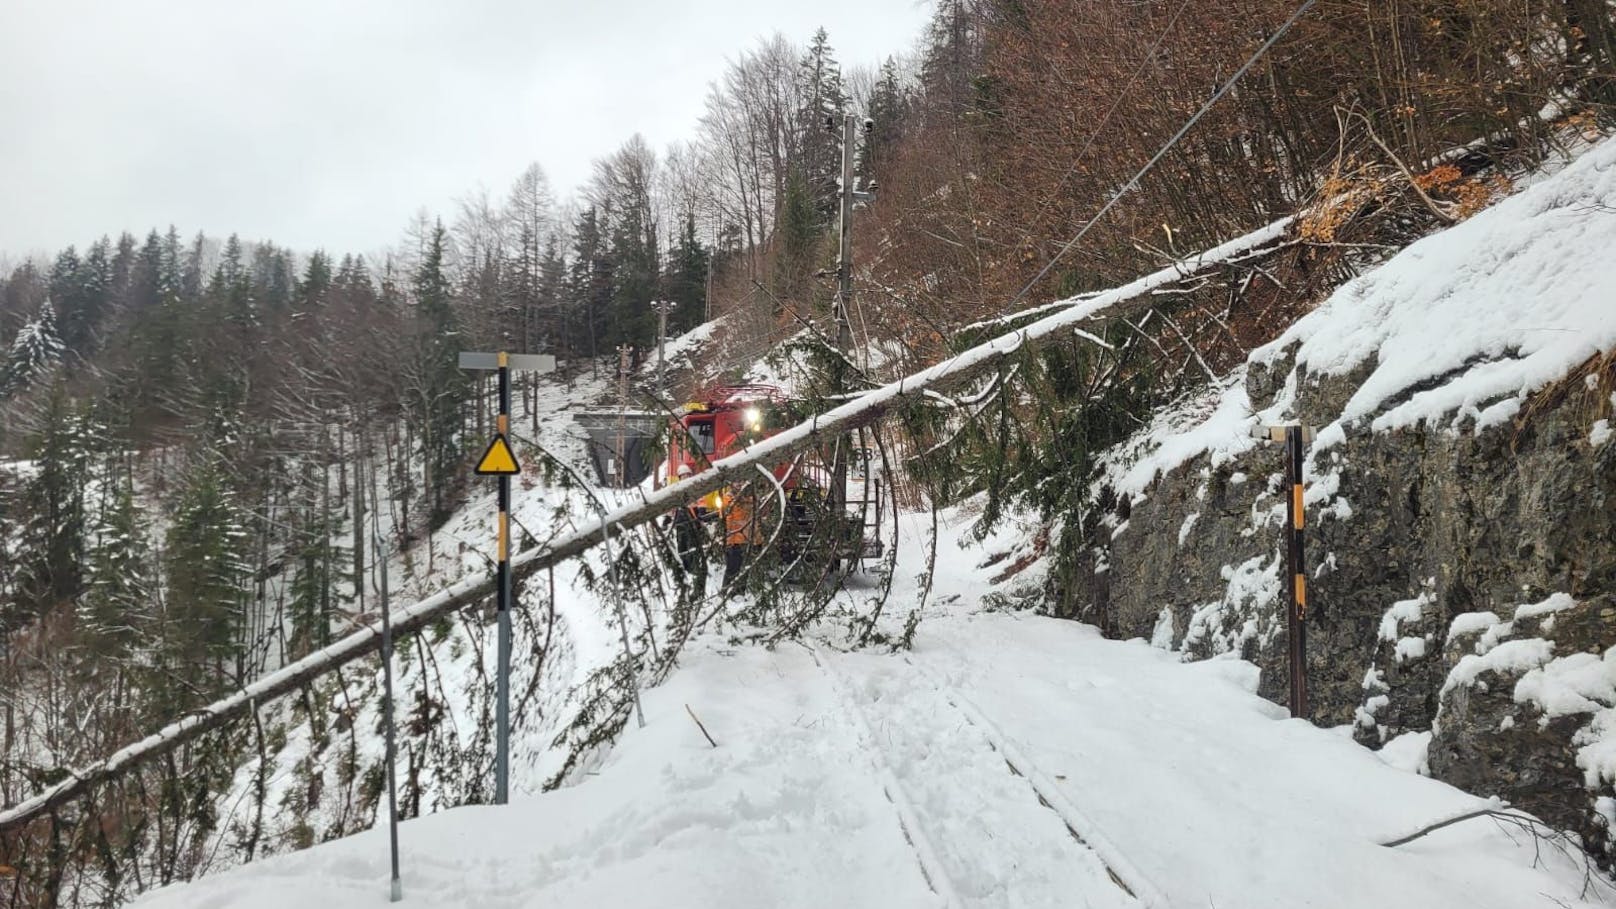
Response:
461,351,556,805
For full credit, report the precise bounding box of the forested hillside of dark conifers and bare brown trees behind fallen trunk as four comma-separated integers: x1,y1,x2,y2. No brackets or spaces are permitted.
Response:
0,0,1616,904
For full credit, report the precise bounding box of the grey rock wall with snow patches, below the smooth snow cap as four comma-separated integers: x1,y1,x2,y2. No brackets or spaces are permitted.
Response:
1055,351,1616,860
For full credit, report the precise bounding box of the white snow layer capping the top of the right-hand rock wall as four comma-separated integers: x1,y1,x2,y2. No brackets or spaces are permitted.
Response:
1109,139,1616,506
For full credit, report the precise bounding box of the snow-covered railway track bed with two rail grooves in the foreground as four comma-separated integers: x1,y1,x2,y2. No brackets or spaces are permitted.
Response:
139,504,1603,909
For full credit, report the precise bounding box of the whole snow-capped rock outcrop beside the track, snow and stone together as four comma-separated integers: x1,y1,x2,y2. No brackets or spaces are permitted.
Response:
1060,141,1616,873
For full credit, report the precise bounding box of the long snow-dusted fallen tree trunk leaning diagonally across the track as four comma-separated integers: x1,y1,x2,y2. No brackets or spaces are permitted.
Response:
0,217,1293,833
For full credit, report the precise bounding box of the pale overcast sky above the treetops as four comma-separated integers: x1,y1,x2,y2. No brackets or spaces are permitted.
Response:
0,0,929,256
